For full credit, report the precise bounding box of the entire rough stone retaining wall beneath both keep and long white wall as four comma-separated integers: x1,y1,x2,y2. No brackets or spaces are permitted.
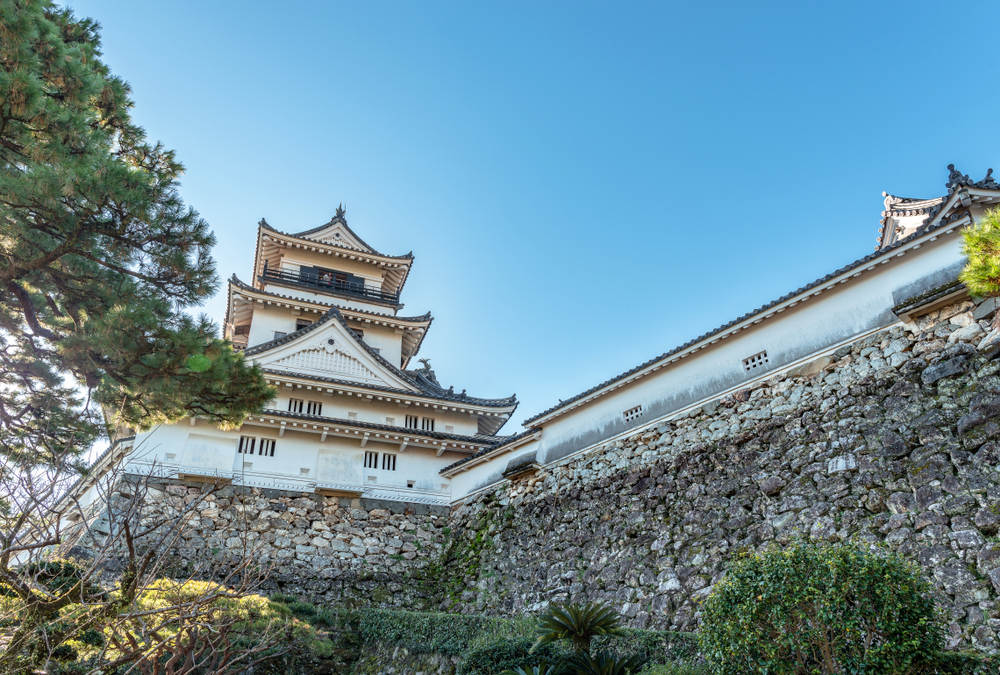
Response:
66,302,1000,652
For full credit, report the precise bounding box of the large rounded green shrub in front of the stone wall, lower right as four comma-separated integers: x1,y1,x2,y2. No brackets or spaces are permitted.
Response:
700,541,944,675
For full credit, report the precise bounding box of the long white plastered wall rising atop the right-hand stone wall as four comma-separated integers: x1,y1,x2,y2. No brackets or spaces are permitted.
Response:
453,224,968,500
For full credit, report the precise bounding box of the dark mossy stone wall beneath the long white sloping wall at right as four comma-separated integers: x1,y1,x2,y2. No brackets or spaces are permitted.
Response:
442,303,1000,652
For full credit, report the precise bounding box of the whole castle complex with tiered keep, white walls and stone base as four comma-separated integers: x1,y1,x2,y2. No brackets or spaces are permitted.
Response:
58,167,1000,651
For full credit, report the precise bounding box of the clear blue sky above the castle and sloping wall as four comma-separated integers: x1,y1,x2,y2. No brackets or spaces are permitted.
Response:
70,0,1000,432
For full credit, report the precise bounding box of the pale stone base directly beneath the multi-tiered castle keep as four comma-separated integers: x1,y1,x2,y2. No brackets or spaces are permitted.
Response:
96,480,448,609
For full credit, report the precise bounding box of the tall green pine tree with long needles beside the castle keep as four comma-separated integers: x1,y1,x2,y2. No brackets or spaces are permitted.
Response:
0,0,273,465
